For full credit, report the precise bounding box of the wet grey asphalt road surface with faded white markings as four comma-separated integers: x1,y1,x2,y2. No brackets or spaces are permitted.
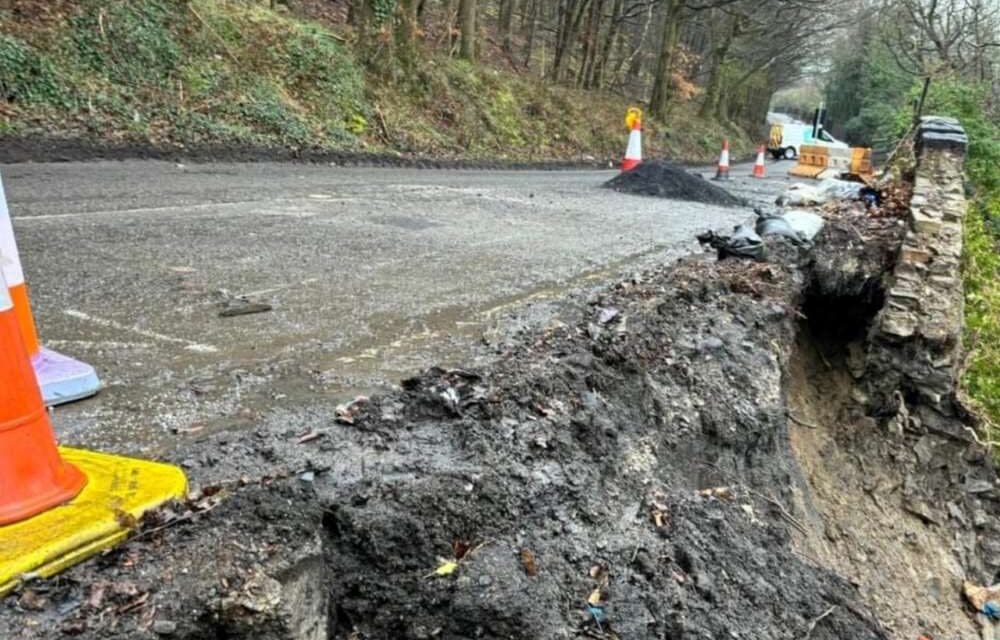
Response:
0,161,788,454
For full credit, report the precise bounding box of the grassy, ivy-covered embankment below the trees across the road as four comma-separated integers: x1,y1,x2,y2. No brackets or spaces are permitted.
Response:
0,0,751,160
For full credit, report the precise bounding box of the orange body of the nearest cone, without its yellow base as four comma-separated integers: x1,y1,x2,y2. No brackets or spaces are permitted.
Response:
0,275,87,525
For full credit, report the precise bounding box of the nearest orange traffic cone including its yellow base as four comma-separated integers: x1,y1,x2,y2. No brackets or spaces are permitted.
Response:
0,254,187,598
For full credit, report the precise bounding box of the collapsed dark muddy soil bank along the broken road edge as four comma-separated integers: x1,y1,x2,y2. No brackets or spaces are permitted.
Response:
0,201,996,640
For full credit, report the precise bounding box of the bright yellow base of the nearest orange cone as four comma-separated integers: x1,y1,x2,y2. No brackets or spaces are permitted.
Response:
0,447,187,597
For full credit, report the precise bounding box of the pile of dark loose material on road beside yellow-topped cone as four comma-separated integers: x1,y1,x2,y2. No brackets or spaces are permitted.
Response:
604,160,746,207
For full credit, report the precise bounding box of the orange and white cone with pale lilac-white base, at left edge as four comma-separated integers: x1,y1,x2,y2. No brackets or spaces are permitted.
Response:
0,171,101,405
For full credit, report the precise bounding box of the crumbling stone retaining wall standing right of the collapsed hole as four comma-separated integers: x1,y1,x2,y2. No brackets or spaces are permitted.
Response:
867,116,968,413
